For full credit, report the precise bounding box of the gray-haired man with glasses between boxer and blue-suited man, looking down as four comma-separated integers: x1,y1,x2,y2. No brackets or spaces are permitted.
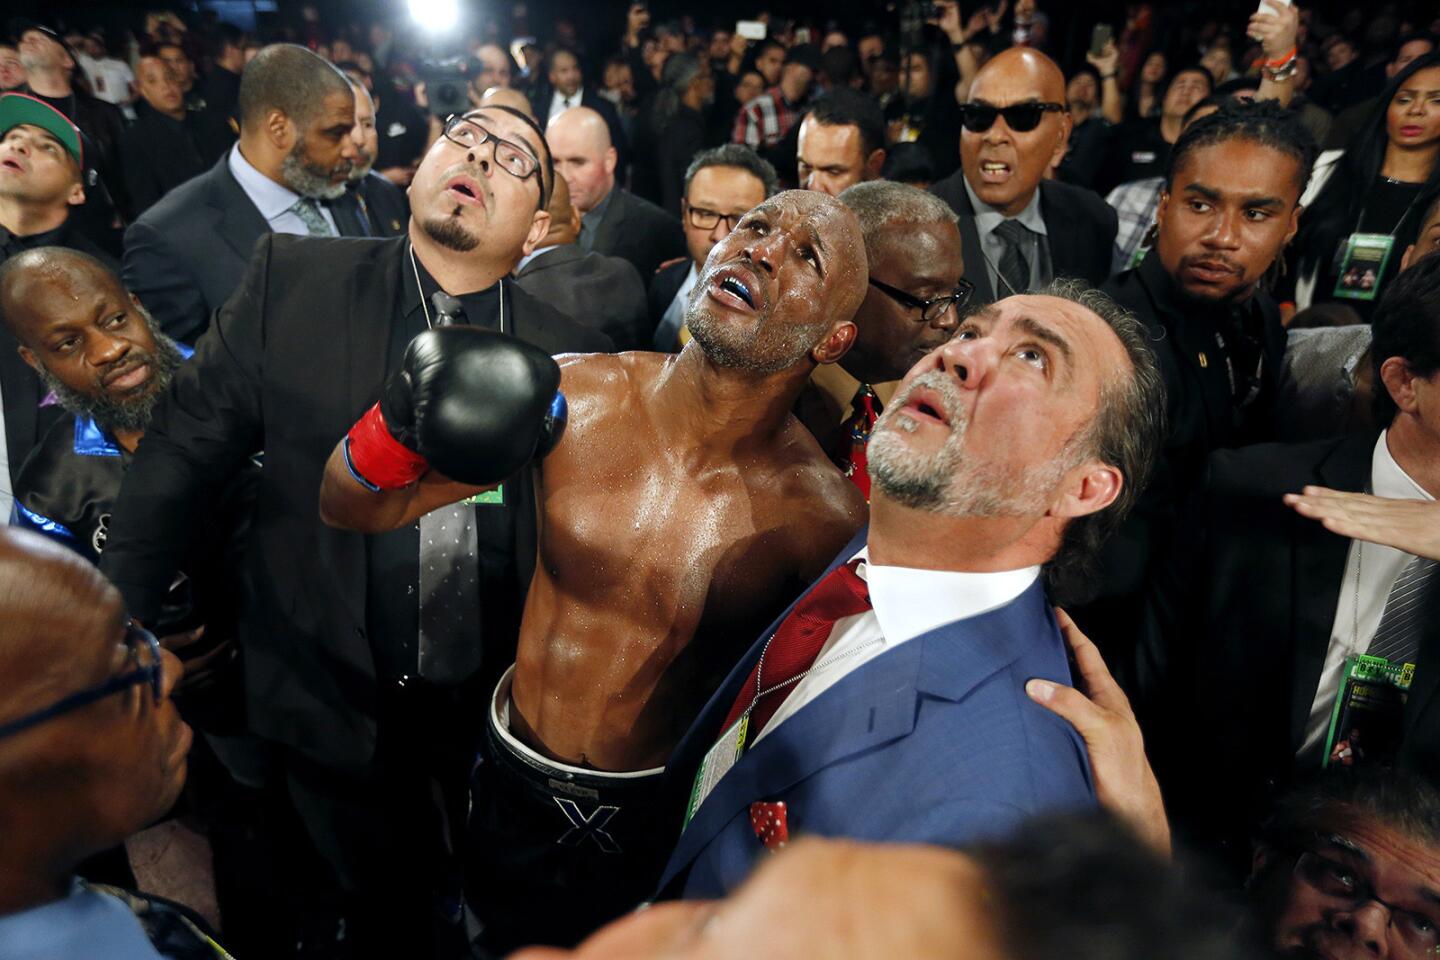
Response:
796,180,971,499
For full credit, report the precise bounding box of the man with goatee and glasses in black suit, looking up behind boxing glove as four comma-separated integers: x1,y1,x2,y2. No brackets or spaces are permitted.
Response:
102,107,609,957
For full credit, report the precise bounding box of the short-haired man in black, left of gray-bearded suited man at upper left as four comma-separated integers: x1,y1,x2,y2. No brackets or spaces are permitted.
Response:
120,56,204,214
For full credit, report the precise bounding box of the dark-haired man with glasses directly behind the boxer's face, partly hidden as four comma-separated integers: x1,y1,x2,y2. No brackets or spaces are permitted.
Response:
649,144,780,353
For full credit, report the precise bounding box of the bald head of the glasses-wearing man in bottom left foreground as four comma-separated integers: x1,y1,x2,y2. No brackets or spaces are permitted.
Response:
0,528,190,892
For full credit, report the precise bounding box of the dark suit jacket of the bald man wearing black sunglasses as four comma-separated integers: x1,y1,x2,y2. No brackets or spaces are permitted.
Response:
930,168,1119,304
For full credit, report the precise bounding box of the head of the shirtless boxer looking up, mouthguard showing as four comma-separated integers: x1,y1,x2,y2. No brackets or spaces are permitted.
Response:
685,190,868,374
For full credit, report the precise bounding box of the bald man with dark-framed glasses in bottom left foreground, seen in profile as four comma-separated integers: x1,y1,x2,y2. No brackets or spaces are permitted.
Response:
0,528,217,960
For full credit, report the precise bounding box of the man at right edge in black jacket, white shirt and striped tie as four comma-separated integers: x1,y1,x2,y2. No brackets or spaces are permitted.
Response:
1135,251,1440,869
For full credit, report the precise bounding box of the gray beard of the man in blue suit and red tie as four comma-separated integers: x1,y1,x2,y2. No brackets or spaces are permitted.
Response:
865,371,1074,517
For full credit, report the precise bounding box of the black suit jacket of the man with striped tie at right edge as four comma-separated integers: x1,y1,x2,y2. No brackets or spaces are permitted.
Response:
1132,433,1440,869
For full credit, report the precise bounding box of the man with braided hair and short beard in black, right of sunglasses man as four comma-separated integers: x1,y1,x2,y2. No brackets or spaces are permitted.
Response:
1073,101,1315,658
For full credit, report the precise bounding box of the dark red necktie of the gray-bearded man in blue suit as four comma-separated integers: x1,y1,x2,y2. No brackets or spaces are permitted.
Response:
721,560,870,743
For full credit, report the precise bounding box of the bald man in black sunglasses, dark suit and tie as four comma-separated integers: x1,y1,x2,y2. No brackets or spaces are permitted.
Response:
930,47,1116,304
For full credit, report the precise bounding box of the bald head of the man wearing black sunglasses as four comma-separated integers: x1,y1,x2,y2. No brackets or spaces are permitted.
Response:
960,47,1070,217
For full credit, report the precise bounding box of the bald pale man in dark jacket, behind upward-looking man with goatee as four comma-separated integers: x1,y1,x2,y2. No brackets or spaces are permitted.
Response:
546,107,685,283
